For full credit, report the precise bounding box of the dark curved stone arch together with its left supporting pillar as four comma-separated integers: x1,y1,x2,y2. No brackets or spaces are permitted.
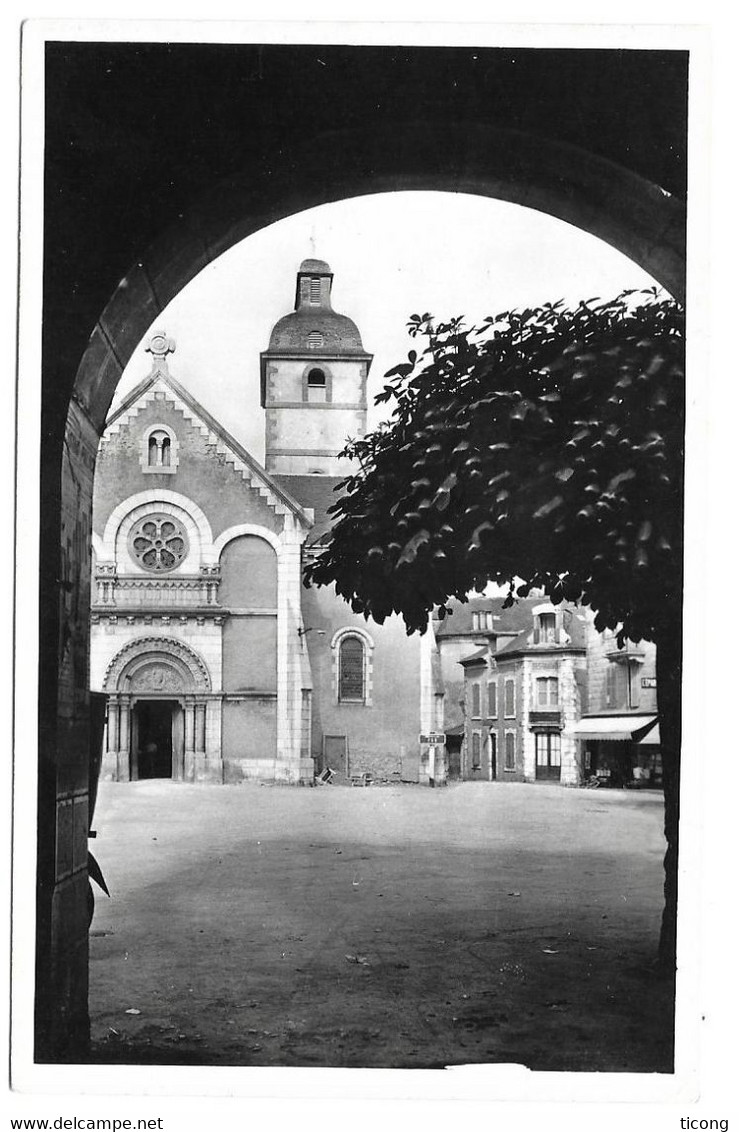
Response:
37,106,685,1057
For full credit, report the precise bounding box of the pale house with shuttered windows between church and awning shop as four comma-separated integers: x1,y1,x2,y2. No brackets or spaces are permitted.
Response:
459,598,588,786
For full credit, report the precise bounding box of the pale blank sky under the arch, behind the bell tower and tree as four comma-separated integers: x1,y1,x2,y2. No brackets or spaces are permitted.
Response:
113,192,654,462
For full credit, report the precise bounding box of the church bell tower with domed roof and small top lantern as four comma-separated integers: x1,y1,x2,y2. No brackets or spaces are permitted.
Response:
260,259,372,475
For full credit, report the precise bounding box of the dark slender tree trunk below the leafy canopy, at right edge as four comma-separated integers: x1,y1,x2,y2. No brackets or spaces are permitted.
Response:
656,609,682,975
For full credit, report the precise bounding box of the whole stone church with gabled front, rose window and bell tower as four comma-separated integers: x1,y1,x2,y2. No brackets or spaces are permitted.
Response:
91,259,444,783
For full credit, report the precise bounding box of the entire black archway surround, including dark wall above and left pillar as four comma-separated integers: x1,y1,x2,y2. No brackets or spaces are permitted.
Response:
36,44,687,1061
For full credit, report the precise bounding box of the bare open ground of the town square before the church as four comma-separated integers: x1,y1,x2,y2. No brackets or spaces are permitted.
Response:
89,781,673,1073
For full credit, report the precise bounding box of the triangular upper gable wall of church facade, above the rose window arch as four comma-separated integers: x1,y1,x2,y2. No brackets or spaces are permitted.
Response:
94,391,284,538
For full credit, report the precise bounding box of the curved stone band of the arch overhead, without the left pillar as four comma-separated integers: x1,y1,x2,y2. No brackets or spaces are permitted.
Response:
75,121,686,431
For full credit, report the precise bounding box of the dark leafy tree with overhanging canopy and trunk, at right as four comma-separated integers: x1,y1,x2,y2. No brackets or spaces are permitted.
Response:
306,289,685,966
